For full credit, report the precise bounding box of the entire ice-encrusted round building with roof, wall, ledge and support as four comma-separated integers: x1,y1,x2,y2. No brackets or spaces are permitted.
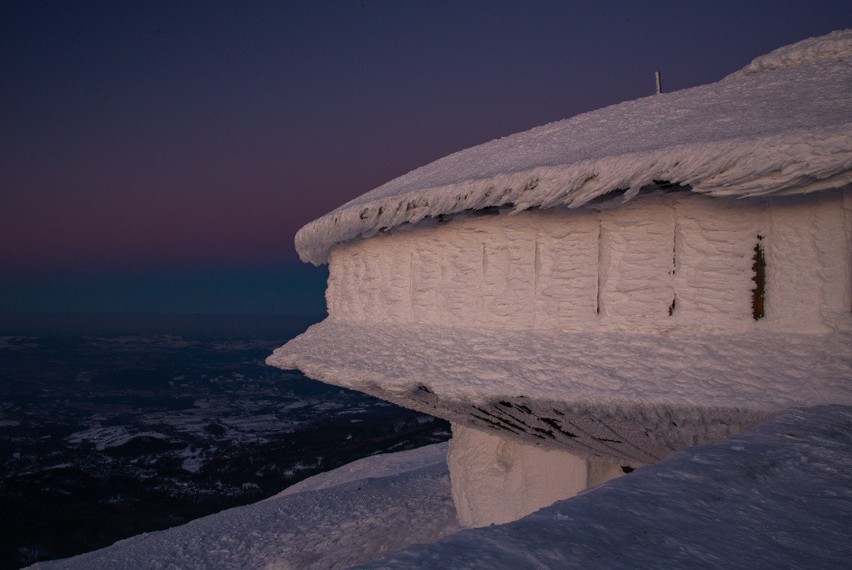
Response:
269,30,852,526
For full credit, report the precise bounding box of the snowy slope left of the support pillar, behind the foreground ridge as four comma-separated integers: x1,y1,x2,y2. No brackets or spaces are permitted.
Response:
28,443,458,570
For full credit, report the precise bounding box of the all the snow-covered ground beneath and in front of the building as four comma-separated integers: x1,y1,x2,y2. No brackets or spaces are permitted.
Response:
30,405,852,569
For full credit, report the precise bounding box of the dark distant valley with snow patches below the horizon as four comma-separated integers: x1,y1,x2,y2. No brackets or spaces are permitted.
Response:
0,326,450,568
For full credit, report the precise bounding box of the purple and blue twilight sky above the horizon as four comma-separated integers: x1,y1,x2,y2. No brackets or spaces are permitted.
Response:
0,0,852,313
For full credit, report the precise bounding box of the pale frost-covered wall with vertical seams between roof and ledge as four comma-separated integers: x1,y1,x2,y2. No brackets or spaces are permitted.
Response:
327,189,852,333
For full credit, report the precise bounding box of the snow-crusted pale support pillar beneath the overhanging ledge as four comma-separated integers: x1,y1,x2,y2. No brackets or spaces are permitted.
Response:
447,424,600,527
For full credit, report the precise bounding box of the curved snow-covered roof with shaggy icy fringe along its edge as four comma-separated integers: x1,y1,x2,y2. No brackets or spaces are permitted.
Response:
296,29,852,264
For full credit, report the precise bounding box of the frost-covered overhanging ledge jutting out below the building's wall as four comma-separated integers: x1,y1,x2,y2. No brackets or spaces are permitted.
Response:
267,319,852,463
